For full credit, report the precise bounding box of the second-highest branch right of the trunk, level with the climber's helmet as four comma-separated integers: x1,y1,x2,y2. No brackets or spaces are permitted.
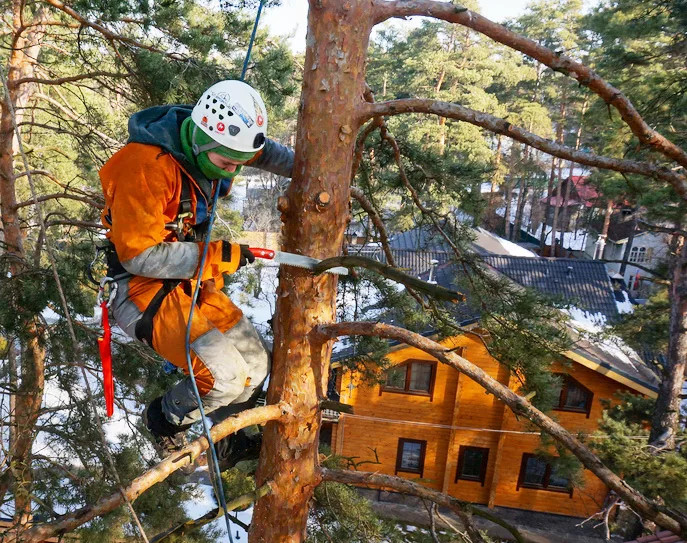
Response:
359,98,687,200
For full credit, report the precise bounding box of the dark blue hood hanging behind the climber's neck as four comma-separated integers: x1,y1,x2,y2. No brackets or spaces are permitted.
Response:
127,104,231,224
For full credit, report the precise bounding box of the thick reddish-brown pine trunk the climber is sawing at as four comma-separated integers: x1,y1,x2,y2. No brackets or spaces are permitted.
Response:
249,0,374,543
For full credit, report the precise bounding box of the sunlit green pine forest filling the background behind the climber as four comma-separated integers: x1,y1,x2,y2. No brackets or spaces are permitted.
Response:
0,0,687,542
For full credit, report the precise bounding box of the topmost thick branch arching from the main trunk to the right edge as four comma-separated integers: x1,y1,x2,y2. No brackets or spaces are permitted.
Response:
375,0,687,176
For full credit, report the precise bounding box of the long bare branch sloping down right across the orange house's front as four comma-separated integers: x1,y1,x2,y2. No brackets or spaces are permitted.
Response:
318,322,687,537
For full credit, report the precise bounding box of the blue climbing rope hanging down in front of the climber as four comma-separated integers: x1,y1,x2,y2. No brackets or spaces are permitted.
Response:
185,0,265,543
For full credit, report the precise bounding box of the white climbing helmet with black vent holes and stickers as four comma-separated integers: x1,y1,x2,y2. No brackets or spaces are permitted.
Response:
191,80,267,155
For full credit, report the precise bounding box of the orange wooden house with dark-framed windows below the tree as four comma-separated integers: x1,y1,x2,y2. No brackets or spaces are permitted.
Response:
323,257,657,517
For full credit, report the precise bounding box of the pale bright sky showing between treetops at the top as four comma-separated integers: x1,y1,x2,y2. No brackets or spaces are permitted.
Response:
260,0,529,52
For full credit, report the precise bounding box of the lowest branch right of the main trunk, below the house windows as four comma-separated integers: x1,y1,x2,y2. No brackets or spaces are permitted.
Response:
321,468,525,543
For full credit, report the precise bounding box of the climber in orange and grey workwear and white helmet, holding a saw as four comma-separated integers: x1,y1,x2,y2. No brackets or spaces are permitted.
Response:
100,80,293,468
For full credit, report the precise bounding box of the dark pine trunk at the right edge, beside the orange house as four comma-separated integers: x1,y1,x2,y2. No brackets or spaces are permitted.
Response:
652,232,687,449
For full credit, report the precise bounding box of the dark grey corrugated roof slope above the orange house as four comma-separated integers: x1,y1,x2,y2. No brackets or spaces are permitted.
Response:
483,255,618,322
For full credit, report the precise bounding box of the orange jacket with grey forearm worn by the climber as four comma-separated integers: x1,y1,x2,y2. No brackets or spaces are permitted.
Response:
100,143,240,309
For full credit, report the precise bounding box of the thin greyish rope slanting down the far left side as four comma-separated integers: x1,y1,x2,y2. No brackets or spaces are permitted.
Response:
0,70,148,543
